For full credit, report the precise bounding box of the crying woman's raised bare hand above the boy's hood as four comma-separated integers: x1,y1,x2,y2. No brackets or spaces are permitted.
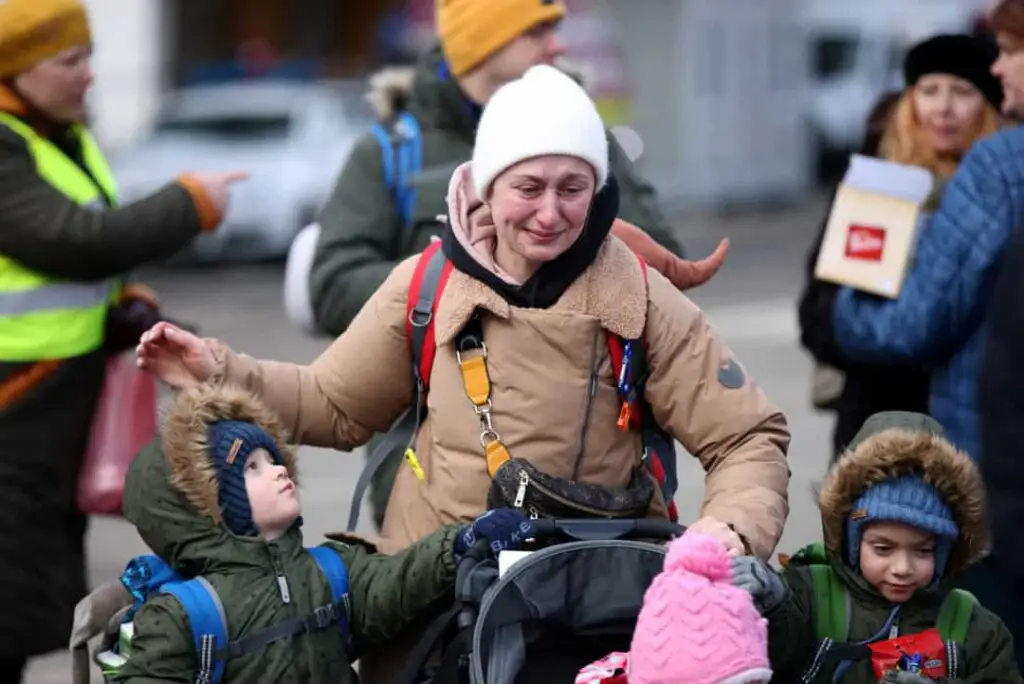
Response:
135,322,216,389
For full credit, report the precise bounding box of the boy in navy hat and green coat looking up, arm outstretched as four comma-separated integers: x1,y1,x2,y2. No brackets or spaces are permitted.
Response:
100,386,532,684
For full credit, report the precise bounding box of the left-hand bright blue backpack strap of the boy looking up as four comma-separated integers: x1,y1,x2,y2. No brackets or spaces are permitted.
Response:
161,578,227,684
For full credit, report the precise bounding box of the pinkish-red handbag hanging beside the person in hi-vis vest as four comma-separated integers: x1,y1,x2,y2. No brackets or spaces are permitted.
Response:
76,350,157,515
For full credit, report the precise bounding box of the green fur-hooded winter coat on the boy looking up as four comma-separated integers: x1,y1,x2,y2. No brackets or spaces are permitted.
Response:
114,388,458,684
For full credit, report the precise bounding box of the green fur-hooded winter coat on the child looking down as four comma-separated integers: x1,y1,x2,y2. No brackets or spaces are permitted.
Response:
766,413,1024,684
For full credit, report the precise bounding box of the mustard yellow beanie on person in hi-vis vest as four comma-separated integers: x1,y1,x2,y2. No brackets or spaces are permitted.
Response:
0,0,92,79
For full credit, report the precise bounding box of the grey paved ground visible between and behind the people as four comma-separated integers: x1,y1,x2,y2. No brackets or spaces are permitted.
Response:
26,193,829,684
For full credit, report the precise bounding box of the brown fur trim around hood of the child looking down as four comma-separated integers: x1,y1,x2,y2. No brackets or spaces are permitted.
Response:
818,427,988,574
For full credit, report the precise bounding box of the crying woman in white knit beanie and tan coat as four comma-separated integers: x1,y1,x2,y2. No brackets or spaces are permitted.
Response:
139,67,788,573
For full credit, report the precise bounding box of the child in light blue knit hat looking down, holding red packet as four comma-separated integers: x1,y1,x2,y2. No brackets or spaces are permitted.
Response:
733,412,1024,684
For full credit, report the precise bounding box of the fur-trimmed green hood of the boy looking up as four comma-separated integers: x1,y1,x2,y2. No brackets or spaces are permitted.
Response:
124,386,302,574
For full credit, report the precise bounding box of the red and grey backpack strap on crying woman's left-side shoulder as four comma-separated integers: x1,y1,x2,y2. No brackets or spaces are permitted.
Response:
406,241,452,401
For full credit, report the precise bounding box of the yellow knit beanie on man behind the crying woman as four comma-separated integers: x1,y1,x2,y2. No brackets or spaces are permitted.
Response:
436,0,565,77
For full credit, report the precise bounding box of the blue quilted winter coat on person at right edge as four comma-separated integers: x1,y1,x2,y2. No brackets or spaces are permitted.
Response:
833,127,1024,458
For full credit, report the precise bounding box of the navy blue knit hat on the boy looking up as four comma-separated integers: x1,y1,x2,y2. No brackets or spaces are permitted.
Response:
207,421,285,537
